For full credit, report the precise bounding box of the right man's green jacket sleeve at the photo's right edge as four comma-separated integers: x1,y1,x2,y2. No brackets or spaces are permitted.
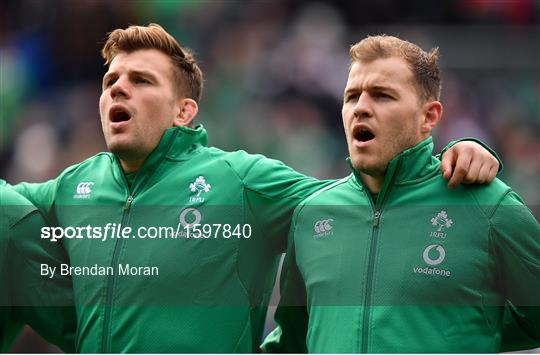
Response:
490,191,540,351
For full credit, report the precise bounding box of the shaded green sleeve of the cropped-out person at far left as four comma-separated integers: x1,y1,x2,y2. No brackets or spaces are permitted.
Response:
8,197,77,352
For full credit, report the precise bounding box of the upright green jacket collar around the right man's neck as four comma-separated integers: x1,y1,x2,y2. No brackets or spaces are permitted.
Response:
347,137,440,190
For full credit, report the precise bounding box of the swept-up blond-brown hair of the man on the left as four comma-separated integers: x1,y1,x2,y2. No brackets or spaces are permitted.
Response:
101,23,203,102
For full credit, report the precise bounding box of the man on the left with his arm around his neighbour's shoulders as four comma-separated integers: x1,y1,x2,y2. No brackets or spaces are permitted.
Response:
11,25,497,353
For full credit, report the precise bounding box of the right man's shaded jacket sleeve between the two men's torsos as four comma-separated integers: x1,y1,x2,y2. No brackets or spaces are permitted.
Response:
261,228,308,353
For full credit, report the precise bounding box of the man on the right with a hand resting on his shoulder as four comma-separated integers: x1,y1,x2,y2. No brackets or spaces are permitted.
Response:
263,35,540,353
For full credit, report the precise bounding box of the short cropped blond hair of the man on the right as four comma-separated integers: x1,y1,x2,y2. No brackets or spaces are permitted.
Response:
349,34,441,102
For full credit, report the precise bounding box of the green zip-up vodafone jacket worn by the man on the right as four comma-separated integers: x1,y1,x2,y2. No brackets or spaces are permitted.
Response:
263,138,540,353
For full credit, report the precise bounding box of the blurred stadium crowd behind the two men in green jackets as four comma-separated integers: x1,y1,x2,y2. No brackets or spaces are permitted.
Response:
0,0,540,352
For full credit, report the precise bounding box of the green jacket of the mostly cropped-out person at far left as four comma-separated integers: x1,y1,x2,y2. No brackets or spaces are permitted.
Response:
0,186,76,352
